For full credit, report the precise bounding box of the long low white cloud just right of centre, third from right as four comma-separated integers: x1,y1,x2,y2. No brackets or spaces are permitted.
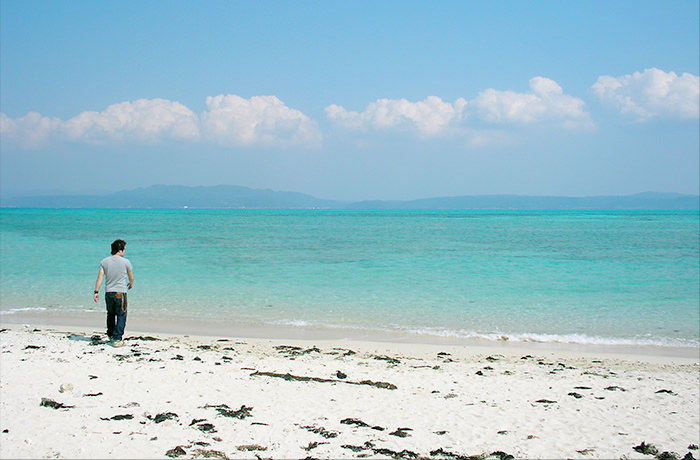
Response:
326,96,467,137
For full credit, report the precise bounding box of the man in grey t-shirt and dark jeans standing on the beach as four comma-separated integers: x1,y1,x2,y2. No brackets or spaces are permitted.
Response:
95,240,134,347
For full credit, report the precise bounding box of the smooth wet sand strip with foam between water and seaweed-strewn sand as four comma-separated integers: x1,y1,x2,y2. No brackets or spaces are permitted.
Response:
0,311,700,364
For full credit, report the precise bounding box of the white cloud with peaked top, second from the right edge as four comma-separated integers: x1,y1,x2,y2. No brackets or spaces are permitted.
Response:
470,77,591,127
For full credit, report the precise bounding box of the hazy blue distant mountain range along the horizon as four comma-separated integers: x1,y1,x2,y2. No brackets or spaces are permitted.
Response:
0,185,700,210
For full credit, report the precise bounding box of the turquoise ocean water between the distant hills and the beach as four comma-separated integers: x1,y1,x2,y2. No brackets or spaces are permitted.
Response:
0,209,700,347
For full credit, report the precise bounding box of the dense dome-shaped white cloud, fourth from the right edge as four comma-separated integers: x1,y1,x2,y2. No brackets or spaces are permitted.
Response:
201,94,321,146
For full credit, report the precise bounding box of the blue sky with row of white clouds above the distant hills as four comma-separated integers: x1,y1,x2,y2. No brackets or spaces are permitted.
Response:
0,0,700,200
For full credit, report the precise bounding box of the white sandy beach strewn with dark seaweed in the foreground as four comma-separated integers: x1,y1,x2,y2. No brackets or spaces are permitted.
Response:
0,324,700,459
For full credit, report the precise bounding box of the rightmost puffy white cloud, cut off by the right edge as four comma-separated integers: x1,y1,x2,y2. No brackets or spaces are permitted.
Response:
592,68,700,121
